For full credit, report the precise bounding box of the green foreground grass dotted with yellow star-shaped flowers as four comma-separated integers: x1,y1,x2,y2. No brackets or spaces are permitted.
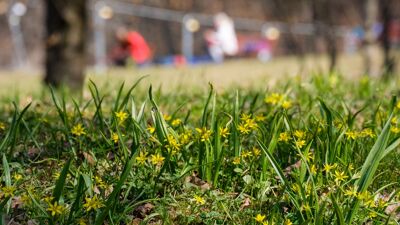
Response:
0,57,400,225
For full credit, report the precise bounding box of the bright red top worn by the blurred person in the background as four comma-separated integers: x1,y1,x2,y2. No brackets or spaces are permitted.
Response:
126,31,151,64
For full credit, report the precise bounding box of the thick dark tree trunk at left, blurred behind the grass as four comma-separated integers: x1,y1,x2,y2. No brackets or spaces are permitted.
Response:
44,0,87,89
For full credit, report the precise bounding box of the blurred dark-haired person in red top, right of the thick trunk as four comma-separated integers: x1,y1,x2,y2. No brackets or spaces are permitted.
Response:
111,27,152,67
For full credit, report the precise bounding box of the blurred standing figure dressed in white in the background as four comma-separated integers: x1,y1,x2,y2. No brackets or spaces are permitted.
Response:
204,13,239,62
